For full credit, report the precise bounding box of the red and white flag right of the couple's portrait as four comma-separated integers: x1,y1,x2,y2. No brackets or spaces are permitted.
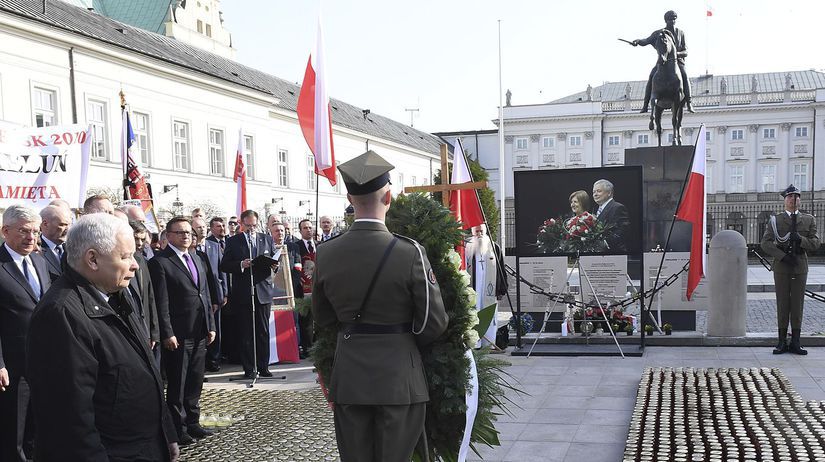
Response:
676,125,708,300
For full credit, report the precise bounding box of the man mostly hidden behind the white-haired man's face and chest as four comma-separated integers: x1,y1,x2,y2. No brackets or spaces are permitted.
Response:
128,220,160,360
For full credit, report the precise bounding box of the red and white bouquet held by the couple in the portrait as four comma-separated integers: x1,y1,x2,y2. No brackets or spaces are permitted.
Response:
536,212,611,253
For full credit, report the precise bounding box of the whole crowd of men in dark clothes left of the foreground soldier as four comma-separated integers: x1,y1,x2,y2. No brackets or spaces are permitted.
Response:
0,196,340,462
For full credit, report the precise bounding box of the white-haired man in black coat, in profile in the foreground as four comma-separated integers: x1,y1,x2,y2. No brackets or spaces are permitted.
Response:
28,213,178,462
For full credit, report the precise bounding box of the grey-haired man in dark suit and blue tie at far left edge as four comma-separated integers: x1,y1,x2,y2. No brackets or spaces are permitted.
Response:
0,205,51,462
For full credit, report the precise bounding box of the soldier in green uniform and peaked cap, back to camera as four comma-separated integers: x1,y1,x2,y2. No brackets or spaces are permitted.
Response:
312,151,448,462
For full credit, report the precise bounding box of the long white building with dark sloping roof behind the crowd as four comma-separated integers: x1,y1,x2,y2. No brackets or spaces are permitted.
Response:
0,0,441,221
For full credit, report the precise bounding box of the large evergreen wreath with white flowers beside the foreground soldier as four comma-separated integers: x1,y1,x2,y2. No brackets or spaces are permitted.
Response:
312,194,517,462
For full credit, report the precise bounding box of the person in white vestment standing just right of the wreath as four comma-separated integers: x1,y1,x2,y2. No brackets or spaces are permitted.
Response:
464,224,507,348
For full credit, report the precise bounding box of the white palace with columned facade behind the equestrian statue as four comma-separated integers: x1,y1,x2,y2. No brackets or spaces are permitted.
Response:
437,70,825,246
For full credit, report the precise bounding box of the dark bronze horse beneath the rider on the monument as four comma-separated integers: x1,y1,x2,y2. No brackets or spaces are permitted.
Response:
649,29,685,146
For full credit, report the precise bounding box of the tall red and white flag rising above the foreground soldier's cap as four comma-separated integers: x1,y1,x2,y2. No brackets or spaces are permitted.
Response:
297,15,336,186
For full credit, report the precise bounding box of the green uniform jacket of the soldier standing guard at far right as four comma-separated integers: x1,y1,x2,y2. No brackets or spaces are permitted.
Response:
760,211,820,274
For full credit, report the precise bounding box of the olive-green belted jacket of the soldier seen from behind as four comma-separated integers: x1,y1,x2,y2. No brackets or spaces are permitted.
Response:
312,220,448,405
